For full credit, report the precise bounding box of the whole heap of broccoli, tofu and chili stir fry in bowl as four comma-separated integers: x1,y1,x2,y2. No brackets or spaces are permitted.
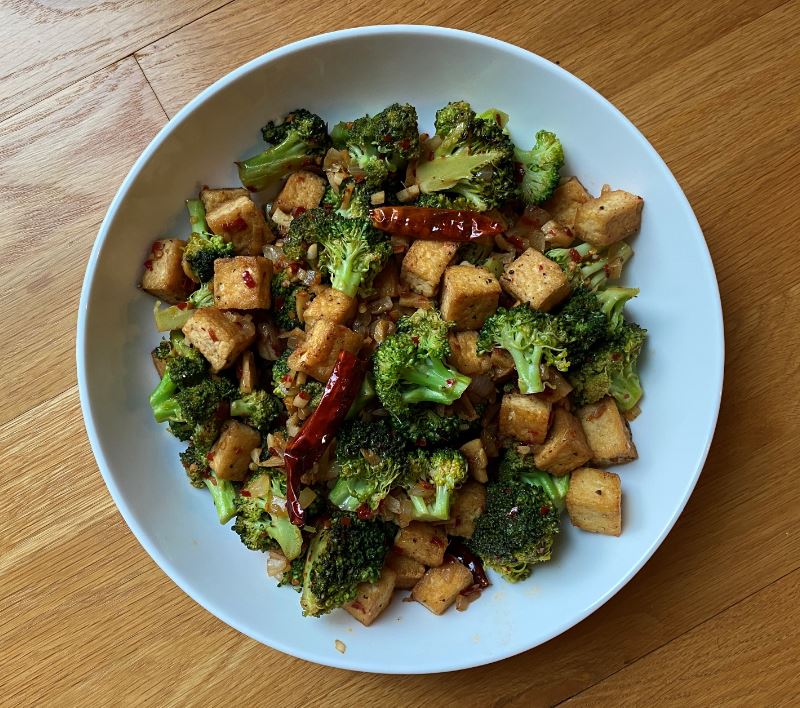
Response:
141,101,646,625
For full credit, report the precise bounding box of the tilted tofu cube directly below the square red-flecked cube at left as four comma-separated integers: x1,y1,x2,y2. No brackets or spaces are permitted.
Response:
183,307,256,373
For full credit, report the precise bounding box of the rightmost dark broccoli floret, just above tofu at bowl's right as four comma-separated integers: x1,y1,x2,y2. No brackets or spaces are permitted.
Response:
569,322,647,411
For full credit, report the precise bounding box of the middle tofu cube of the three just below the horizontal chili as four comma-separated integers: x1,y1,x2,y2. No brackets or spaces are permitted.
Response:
441,265,501,330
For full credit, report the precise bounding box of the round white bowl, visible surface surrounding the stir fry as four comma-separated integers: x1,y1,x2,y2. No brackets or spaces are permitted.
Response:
77,26,723,673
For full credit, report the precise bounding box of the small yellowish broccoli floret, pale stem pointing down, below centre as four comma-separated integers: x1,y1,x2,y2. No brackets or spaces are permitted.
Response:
403,449,467,521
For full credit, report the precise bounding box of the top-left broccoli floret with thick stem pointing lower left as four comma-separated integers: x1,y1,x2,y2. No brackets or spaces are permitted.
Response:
236,108,330,192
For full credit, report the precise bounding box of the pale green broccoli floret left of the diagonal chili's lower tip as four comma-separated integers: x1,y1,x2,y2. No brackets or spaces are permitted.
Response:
233,470,303,560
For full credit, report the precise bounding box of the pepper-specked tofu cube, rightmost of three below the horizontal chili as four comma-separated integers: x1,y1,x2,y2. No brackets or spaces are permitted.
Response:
500,248,570,312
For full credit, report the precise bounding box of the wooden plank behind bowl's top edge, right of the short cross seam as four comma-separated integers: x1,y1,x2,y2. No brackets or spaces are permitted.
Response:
136,0,785,116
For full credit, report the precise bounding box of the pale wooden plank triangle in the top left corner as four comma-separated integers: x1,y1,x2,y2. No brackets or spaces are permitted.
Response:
0,0,231,121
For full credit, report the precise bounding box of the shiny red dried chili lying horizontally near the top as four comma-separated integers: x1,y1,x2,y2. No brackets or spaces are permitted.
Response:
370,207,504,241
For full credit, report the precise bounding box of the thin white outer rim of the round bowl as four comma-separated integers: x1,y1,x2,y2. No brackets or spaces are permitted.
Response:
76,25,724,673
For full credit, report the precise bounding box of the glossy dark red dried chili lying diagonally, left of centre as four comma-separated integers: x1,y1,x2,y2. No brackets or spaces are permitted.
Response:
283,351,364,526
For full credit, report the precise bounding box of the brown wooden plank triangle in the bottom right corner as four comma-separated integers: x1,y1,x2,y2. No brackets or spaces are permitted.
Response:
561,571,800,708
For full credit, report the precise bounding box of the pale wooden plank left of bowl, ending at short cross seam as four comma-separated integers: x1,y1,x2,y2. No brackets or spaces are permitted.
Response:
0,58,166,423
